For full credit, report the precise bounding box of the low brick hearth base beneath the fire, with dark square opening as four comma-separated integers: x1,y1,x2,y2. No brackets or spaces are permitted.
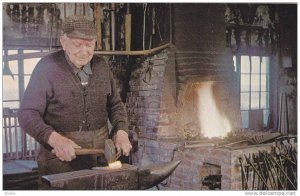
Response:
140,140,271,190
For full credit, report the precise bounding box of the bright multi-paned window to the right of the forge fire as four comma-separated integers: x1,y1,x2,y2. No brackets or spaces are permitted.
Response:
233,55,270,128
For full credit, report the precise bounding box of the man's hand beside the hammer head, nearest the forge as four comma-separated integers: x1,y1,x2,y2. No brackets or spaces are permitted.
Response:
115,130,132,156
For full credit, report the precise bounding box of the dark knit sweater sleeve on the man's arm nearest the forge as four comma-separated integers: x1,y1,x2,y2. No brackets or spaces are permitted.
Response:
107,71,128,134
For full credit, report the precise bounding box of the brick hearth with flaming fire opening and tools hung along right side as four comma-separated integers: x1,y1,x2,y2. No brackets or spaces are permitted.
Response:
130,80,297,190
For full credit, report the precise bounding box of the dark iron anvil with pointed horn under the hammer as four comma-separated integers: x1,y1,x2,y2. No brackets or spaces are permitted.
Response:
42,160,181,190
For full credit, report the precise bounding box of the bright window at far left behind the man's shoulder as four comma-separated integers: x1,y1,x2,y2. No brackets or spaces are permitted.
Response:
2,50,41,160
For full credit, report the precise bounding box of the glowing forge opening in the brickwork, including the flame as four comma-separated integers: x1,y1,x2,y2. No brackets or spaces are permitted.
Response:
178,81,241,140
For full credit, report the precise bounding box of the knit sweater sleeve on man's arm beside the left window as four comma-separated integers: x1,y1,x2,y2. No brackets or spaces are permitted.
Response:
18,58,54,144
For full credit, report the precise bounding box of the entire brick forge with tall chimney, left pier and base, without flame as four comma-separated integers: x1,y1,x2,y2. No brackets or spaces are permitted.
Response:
126,5,282,190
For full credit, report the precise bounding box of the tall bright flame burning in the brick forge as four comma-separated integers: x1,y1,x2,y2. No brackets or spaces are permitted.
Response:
197,82,231,138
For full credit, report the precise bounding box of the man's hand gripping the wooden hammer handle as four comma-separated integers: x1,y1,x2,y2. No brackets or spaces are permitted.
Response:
48,132,81,161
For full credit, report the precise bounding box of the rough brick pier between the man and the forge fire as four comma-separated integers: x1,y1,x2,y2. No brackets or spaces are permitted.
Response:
126,50,176,140
